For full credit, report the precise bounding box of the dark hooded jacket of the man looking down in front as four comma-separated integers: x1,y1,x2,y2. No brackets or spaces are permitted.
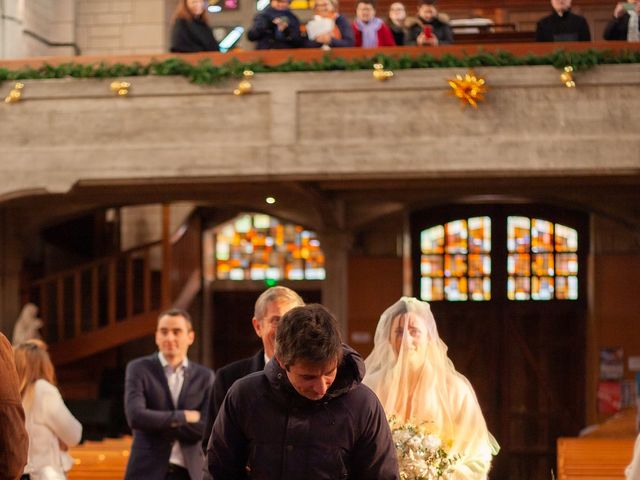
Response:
204,346,399,480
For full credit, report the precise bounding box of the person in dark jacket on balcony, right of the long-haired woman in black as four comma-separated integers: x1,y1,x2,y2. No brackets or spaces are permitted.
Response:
247,0,304,50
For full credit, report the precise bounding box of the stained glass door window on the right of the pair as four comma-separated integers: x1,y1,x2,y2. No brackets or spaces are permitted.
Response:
507,216,578,300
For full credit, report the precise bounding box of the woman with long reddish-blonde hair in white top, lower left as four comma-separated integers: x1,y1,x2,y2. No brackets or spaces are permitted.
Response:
14,340,82,480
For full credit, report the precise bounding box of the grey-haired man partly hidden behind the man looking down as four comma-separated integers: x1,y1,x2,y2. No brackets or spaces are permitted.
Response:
202,286,304,452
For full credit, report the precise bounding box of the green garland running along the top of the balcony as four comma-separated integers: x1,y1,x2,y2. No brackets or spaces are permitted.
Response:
0,50,640,85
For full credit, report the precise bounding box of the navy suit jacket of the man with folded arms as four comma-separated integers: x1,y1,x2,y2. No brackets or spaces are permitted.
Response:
124,353,214,480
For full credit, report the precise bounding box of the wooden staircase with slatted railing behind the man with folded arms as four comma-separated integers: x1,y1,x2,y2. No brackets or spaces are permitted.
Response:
29,206,201,366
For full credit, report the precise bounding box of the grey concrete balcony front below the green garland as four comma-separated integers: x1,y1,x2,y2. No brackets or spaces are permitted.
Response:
0,65,640,200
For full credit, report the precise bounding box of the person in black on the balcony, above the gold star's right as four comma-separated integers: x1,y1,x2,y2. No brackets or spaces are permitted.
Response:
536,0,591,42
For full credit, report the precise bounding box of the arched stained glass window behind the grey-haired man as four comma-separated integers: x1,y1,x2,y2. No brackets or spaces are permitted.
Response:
214,213,325,280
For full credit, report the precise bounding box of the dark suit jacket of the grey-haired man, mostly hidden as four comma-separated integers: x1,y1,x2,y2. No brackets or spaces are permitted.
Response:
202,350,264,452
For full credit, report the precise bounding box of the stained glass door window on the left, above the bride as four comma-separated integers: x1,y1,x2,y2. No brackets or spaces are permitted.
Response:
420,217,491,301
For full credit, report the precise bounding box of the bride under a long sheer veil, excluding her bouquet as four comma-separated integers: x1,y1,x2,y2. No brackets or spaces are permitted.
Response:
364,297,499,480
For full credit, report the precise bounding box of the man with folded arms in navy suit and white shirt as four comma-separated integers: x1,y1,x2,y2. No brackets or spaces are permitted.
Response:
124,309,214,480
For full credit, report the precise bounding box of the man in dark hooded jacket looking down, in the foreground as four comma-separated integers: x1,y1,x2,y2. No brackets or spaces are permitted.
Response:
204,304,399,480
